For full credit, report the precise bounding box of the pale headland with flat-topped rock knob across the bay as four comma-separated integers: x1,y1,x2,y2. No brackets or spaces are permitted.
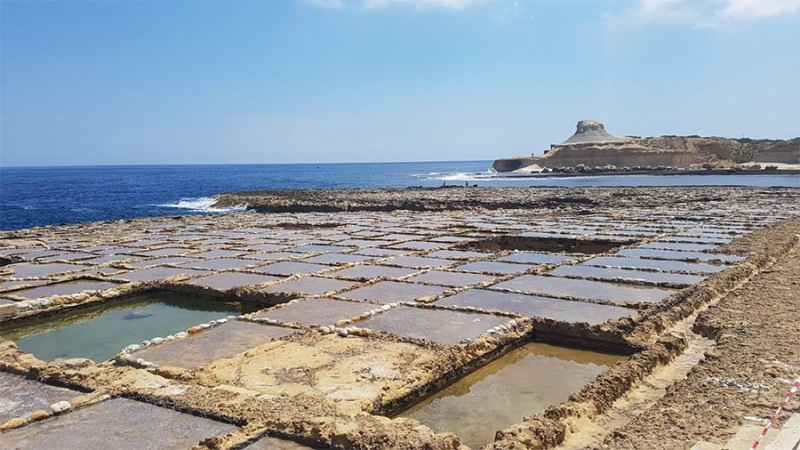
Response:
493,120,800,174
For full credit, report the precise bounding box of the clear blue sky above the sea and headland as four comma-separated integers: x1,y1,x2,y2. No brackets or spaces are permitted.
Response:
0,0,800,166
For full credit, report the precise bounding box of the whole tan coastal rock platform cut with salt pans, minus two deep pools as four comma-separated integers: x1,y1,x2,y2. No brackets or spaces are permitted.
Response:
0,187,800,449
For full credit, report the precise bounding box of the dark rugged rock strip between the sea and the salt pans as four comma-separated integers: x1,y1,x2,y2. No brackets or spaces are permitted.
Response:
214,186,798,213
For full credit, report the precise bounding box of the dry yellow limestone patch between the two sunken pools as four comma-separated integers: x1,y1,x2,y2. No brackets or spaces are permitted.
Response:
197,335,440,411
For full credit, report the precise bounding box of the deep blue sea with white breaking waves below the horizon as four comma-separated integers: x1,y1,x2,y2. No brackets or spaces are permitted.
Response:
0,161,800,230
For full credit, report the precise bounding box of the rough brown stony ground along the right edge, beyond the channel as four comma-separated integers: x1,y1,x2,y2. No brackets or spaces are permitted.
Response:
603,222,800,449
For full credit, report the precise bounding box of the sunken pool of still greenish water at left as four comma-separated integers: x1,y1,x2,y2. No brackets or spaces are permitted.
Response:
0,294,258,362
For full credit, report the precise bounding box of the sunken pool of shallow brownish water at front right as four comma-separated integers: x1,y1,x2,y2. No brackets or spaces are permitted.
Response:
398,343,627,448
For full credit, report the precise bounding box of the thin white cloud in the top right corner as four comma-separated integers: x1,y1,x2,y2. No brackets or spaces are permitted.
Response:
605,0,800,28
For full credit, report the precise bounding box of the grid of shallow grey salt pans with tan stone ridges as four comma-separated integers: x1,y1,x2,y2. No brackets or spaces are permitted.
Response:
0,185,800,449
